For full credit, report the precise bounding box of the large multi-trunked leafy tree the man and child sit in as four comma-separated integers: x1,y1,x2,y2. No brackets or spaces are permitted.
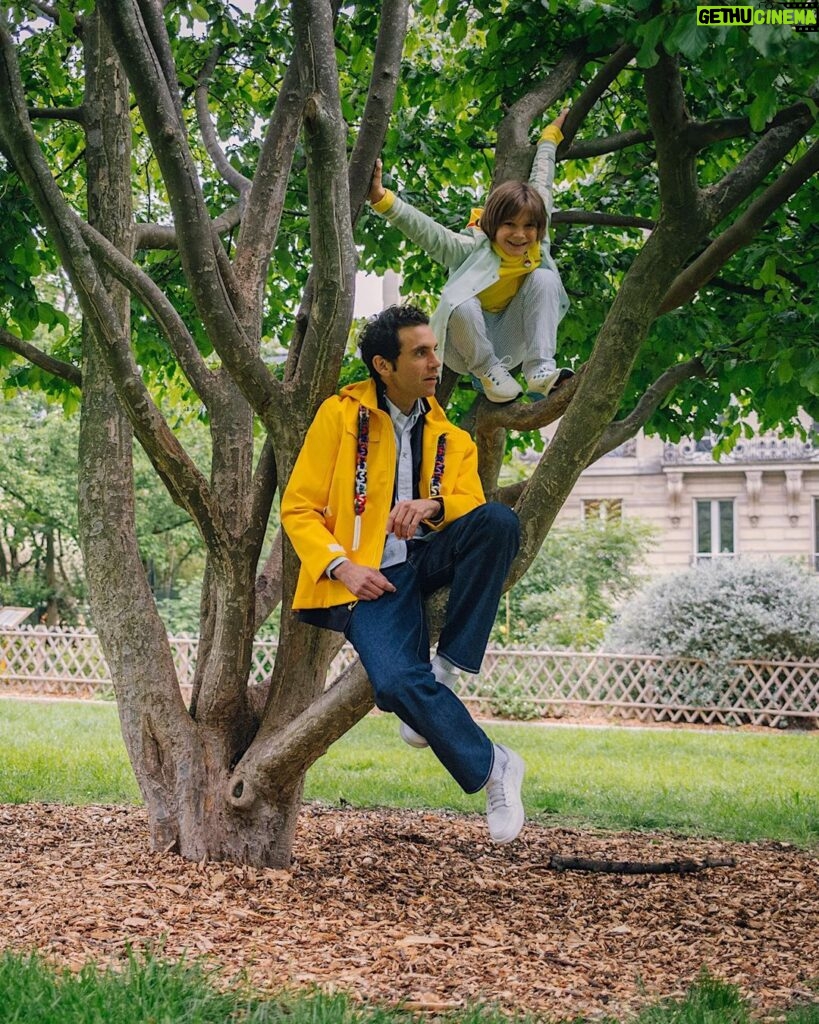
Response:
0,0,819,864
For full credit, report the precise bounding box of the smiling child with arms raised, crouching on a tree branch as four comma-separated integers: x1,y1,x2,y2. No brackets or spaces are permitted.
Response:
369,110,572,402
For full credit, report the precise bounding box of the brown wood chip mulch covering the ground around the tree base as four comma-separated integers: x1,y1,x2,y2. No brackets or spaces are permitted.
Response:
0,805,819,1020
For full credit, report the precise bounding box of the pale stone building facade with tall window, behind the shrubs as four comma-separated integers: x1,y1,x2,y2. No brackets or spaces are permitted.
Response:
558,434,819,572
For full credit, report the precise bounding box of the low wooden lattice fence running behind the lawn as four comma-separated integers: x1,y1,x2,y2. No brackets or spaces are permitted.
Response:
0,627,819,725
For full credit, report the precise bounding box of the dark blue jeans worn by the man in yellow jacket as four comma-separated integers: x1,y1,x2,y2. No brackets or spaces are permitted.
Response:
346,502,520,793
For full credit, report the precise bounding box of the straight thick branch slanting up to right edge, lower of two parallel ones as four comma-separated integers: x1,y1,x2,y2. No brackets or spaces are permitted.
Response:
659,142,819,313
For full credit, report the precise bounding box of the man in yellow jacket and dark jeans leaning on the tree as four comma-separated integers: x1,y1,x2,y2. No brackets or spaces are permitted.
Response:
282,306,523,843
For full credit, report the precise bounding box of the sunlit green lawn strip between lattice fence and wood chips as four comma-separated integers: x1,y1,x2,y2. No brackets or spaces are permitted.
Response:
0,698,819,847
